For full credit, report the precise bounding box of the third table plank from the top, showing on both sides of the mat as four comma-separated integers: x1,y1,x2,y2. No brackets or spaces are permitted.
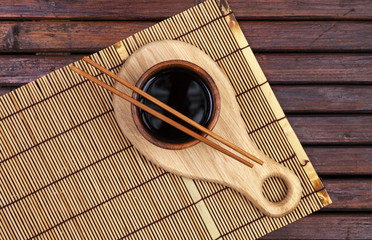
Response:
0,53,372,86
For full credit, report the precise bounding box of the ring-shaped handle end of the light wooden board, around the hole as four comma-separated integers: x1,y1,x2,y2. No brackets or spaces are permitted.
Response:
255,162,302,217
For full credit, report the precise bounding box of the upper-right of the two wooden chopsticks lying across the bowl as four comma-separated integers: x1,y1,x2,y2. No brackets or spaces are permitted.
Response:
83,57,263,165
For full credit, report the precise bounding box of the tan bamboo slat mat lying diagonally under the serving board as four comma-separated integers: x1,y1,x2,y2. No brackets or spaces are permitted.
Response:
0,0,331,239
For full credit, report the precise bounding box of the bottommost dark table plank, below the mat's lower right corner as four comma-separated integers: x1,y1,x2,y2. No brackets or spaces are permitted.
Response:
262,213,372,239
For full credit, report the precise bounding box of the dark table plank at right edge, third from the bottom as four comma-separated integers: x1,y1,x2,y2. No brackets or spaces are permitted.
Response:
305,146,372,174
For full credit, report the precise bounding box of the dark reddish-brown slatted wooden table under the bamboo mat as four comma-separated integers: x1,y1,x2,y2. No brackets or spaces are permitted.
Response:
0,0,372,239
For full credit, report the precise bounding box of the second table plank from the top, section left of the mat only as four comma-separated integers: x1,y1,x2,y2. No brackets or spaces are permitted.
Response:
0,21,154,52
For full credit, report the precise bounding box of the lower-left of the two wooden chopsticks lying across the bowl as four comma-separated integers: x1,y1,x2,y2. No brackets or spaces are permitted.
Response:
70,66,253,167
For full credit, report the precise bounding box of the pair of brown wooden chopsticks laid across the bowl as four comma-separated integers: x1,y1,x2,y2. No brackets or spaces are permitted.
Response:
70,57,263,167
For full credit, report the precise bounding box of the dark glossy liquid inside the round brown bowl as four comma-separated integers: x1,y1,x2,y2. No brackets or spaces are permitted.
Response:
139,67,213,144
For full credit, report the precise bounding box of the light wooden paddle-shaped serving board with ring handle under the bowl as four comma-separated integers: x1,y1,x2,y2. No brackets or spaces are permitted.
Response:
112,40,302,217
